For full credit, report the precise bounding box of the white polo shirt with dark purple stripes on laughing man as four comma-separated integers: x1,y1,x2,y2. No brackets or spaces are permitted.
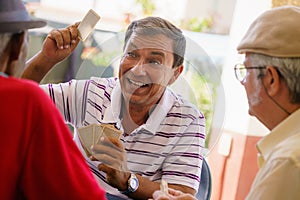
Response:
41,77,205,198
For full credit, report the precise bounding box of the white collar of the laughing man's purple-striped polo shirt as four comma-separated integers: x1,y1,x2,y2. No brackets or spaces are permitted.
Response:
103,81,178,135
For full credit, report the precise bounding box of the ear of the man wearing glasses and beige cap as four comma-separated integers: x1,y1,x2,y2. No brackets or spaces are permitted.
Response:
263,66,282,97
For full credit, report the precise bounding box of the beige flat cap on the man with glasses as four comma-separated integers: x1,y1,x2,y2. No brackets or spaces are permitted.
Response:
237,6,300,57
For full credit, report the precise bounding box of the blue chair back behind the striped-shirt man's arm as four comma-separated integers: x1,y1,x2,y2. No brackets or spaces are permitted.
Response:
196,159,212,200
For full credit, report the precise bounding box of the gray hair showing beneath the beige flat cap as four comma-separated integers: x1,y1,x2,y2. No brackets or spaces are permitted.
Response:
249,53,300,103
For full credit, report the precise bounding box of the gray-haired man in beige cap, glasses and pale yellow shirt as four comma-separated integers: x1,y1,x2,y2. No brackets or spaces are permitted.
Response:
235,6,300,200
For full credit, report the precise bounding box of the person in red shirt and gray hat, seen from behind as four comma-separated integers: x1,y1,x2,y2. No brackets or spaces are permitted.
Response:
0,0,106,200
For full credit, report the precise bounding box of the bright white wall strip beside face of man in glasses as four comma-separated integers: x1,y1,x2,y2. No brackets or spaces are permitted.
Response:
222,0,271,136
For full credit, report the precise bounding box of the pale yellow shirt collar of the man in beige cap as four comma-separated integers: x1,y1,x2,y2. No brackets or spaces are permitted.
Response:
256,109,300,160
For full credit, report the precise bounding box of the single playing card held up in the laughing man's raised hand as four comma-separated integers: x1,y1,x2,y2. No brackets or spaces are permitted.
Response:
78,9,101,41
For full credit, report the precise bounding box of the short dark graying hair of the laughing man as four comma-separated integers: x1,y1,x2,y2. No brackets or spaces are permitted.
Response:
124,17,186,67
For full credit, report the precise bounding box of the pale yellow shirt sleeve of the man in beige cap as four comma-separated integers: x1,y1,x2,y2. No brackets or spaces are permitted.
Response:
247,158,300,200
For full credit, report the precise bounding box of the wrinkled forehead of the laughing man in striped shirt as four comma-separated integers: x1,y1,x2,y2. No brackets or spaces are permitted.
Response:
125,32,174,54
